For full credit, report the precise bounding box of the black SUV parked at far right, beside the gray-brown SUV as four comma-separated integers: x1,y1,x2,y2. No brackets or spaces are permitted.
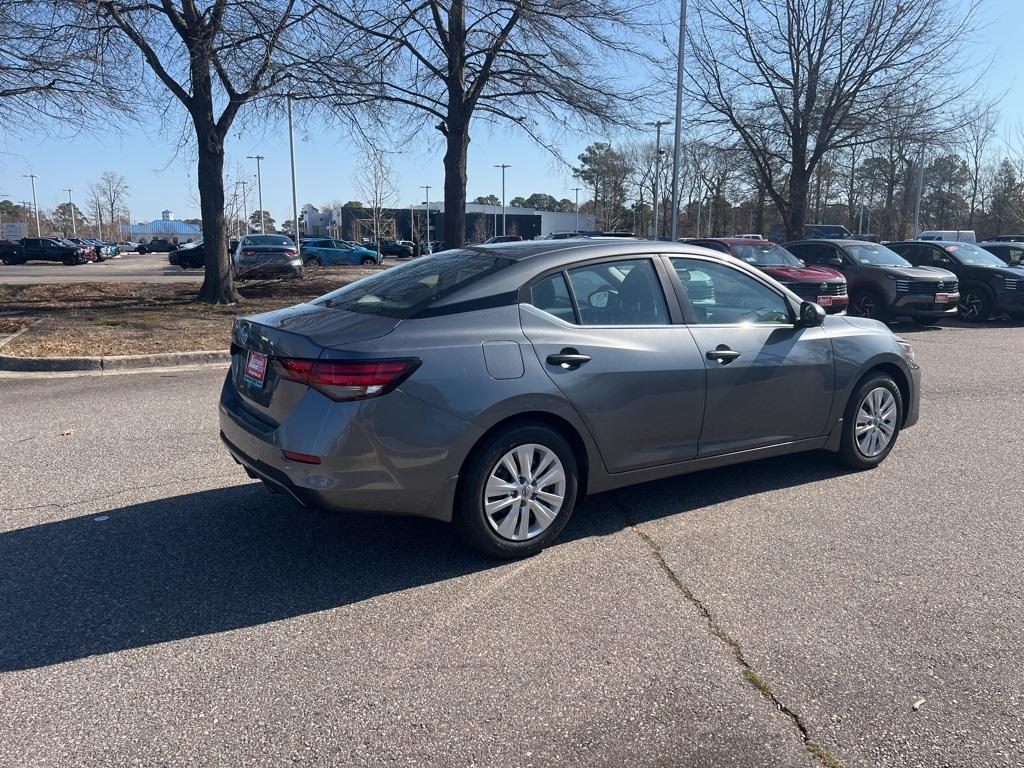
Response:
889,240,1024,323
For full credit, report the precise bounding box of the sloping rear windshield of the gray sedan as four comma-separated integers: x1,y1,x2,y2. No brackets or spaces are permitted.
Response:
312,251,515,319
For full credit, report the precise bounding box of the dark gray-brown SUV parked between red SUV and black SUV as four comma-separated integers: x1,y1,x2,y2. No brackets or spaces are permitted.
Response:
785,240,959,324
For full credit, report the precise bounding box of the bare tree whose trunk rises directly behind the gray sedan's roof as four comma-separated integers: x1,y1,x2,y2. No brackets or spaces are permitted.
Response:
319,0,638,247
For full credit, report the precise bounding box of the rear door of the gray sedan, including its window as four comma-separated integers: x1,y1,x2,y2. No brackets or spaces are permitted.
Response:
520,256,706,472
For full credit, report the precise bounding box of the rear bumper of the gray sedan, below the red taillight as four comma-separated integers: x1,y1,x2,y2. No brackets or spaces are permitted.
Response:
219,373,481,521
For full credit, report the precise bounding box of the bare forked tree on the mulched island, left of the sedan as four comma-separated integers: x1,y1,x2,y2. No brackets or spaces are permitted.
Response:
86,0,347,303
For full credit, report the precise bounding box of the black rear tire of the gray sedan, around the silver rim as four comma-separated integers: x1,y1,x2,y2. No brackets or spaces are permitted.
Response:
453,424,579,560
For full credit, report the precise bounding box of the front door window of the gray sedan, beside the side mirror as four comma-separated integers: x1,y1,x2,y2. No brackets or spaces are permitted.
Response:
672,258,793,326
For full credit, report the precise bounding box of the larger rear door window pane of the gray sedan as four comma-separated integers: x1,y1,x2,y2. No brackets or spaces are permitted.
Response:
568,259,669,326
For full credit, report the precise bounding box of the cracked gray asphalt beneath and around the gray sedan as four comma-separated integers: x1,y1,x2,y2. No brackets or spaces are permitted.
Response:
0,321,1024,767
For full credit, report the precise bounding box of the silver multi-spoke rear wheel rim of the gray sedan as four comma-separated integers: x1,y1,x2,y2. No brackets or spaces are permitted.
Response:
483,443,565,542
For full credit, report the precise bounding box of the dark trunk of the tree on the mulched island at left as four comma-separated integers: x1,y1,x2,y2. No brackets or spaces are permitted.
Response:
196,122,242,304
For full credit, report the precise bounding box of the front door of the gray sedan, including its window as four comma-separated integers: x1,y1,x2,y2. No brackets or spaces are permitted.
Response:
670,257,835,457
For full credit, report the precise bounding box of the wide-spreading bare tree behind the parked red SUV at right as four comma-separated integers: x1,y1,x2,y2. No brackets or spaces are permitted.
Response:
688,0,974,238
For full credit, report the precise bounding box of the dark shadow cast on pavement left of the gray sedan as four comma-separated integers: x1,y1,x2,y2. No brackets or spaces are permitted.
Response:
0,483,491,672
